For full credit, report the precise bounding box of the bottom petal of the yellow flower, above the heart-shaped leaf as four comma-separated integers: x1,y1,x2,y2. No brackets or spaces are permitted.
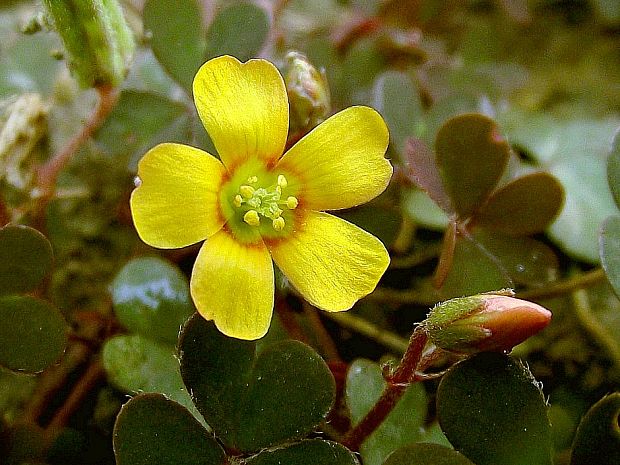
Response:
190,229,274,340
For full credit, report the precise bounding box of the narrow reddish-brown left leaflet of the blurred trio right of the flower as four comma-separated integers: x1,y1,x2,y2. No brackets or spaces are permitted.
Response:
405,138,454,214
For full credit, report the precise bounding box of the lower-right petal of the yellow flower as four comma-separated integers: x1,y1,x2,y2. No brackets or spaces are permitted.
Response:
267,211,390,312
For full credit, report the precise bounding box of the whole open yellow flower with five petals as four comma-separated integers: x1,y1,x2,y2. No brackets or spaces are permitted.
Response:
131,56,392,339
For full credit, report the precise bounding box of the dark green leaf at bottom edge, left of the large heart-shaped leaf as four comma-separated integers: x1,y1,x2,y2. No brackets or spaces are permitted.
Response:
113,394,225,465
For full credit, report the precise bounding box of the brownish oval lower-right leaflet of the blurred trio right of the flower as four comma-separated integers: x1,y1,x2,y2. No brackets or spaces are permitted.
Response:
476,172,564,236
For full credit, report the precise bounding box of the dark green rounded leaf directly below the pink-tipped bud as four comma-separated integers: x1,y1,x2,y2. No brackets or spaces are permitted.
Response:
437,352,552,465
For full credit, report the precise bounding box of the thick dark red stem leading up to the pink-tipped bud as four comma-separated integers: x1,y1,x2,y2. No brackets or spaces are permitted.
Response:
342,326,427,451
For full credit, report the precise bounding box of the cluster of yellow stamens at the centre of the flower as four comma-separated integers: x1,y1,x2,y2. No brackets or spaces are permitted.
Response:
233,174,299,231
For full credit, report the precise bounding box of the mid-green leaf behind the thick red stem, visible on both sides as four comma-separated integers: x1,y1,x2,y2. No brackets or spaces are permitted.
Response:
345,359,426,465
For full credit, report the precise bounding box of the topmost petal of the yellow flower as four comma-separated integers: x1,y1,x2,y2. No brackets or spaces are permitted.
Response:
194,56,288,169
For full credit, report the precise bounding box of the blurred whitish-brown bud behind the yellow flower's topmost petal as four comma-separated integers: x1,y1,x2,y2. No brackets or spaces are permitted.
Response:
284,52,331,134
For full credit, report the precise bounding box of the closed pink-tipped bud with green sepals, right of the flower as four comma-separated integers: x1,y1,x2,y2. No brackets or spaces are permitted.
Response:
422,291,551,353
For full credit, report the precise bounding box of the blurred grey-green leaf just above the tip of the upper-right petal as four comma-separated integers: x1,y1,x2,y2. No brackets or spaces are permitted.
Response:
373,71,424,157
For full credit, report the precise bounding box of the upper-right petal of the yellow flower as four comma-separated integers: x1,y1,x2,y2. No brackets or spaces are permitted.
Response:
277,107,392,210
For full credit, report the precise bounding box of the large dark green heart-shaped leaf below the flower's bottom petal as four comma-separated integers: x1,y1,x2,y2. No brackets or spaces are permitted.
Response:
179,314,335,451
